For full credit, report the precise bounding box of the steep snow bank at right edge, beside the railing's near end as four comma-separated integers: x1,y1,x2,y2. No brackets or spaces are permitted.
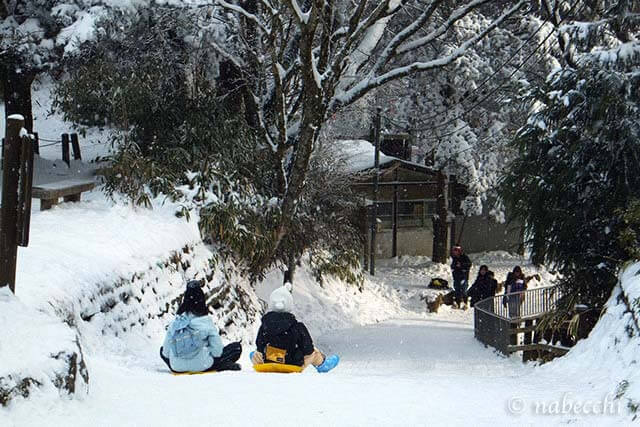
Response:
540,263,640,419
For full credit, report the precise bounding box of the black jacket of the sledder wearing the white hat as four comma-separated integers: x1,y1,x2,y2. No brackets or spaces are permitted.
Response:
256,311,313,366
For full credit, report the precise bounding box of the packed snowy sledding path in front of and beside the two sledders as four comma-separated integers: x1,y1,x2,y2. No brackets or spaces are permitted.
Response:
3,314,615,426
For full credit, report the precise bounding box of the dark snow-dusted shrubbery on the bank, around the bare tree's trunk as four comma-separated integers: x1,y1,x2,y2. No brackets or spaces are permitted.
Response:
57,8,361,288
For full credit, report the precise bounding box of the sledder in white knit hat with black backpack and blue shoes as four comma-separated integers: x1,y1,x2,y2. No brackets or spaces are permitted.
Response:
250,283,340,372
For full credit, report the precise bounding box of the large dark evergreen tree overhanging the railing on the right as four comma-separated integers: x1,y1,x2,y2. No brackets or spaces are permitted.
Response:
502,64,640,309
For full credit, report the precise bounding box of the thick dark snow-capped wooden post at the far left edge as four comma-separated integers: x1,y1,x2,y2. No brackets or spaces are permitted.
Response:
0,114,24,293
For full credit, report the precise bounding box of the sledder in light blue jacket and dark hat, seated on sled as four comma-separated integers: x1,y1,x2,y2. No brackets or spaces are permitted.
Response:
160,280,242,372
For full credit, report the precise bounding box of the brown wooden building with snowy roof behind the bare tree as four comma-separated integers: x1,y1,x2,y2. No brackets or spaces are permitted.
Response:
338,139,522,259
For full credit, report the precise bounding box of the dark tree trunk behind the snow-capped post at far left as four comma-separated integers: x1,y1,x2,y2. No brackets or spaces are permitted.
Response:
0,63,36,132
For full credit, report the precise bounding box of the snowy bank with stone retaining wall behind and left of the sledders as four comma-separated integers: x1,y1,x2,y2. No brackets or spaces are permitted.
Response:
16,191,261,359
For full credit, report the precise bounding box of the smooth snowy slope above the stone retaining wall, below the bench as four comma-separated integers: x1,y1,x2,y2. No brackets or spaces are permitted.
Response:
16,190,200,306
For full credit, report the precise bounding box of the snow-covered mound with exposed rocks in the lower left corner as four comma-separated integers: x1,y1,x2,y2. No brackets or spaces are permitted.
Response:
0,286,89,406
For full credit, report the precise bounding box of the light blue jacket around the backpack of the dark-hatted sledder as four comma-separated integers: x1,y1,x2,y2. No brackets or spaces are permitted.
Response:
162,313,222,372
